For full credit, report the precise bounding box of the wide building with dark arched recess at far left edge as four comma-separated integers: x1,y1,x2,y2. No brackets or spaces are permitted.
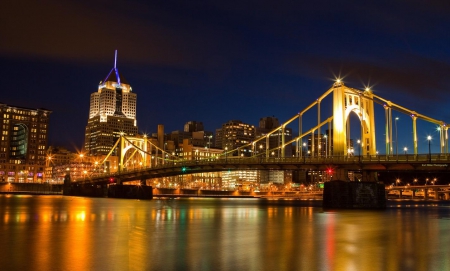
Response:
0,104,51,183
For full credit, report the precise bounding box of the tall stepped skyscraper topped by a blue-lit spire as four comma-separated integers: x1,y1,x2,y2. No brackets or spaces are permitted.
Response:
84,51,138,156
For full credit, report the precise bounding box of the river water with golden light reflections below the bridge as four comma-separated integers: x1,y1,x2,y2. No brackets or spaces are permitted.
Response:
0,195,450,271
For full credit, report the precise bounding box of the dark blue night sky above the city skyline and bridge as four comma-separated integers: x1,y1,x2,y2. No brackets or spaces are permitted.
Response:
0,0,450,152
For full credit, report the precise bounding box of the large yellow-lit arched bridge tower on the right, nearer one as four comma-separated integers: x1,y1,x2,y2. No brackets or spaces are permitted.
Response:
333,80,376,155
